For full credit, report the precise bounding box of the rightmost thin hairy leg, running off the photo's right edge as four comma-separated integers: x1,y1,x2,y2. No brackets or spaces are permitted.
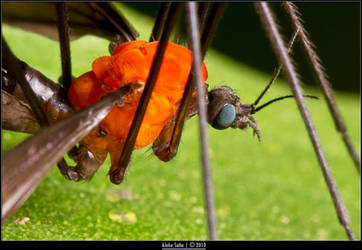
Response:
283,2,361,174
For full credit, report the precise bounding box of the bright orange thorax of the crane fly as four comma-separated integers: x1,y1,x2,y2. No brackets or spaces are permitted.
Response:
68,41,207,149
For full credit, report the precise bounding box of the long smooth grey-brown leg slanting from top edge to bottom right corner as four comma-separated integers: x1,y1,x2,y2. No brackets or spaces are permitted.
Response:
255,2,356,240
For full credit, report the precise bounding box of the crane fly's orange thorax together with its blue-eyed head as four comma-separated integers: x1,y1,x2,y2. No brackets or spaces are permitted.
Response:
68,41,308,184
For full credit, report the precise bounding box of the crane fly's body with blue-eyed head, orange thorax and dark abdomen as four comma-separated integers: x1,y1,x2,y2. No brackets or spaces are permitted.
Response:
3,38,266,184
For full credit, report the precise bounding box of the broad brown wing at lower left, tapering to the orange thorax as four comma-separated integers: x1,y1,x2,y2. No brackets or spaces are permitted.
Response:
1,85,135,221
